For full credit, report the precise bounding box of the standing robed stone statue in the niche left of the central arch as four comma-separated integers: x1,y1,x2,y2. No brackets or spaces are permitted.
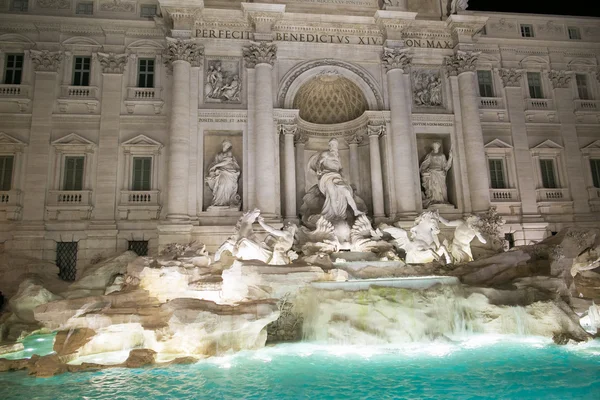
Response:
205,140,240,208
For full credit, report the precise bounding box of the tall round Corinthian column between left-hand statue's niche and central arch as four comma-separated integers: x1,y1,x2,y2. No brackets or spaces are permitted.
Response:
244,42,278,218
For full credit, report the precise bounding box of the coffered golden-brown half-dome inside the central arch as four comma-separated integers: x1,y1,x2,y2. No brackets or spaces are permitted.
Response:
294,73,368,124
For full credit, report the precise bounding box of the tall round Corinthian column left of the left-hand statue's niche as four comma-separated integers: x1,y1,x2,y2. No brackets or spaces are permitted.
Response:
164,38,204,222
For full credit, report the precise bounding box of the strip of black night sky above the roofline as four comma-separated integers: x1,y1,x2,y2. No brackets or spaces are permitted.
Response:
468,0,600,17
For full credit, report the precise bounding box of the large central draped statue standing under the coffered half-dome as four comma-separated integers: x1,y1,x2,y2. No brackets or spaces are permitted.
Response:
308,138,364,221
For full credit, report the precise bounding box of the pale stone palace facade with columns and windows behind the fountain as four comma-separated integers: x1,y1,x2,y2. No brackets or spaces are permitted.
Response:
0,0,600,268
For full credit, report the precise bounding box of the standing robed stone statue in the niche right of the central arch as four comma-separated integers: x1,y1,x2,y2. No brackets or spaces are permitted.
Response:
419,141,452,208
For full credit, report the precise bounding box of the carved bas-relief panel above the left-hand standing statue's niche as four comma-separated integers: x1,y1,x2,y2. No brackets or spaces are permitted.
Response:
204,58,242,104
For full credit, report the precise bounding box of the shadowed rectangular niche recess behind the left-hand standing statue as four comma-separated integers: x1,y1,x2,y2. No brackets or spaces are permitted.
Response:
202,130,245,210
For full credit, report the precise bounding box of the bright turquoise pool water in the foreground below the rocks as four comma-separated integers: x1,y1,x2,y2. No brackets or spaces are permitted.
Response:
0,337,600,400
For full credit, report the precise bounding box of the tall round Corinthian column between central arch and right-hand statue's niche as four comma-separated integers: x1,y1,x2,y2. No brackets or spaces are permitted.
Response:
381,48,419,217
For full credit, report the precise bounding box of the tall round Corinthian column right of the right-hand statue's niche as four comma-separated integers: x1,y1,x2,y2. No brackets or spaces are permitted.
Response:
446,50,490,212
